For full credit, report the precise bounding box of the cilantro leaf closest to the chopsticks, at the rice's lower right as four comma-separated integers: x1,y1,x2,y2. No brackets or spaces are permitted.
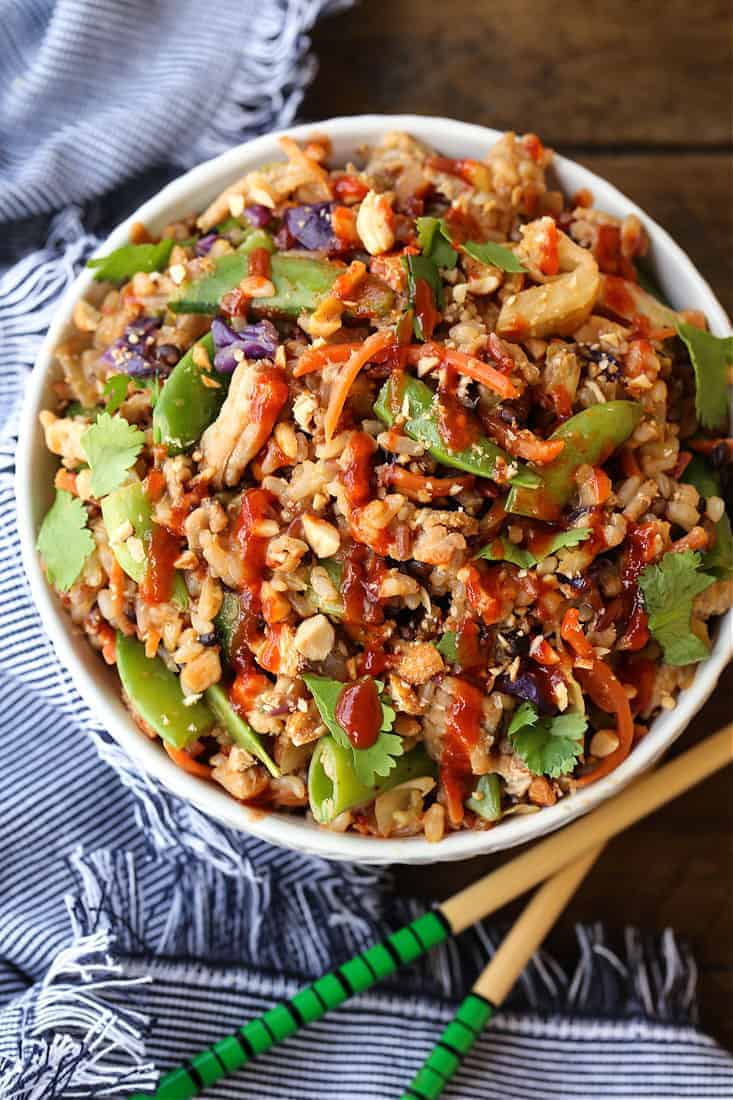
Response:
507,703,588,779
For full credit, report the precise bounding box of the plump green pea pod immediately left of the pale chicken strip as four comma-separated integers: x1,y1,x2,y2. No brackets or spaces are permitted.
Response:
153,332,229,454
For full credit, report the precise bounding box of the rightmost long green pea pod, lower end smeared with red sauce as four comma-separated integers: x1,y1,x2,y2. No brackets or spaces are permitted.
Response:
506,402,644,521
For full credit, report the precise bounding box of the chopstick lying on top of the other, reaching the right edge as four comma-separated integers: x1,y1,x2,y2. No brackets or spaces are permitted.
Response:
132,723,733,1100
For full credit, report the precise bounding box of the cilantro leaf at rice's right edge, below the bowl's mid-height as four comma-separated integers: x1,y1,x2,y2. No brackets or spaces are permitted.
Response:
638,550,714,664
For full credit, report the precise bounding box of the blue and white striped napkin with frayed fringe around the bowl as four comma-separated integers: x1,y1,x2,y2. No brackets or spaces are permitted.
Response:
0,0,733,1100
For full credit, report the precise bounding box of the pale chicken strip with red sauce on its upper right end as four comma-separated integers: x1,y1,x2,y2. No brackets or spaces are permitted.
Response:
201,360,288,488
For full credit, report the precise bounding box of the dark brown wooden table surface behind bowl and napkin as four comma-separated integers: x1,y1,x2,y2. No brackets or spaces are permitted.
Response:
303,0,733,1047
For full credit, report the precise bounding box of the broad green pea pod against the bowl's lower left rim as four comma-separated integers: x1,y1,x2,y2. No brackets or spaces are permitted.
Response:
117,631,215,749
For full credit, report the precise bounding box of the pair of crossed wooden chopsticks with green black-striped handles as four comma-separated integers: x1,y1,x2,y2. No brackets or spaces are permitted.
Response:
132,724,733,1100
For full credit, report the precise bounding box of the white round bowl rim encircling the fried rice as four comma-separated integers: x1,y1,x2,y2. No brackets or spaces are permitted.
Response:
17,116,733,864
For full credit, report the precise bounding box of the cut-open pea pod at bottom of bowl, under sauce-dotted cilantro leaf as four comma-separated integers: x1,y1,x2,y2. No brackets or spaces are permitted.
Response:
308,734,437,825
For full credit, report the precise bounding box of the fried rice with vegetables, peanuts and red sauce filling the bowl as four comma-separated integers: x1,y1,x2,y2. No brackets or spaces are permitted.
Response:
39,133,733,840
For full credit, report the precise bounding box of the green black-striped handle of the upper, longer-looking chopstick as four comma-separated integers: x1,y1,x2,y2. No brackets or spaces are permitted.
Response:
132,910,452,1100
